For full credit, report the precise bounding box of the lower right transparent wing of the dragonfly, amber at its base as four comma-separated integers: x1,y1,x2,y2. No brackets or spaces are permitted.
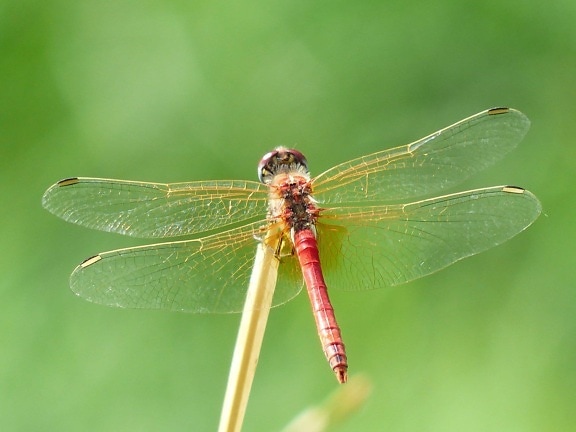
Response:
318,186,541,290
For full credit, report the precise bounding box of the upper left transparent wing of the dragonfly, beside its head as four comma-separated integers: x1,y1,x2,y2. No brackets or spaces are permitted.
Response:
42,177,268,238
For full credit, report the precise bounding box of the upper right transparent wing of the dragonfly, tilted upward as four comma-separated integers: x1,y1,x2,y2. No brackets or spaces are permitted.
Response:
313,108,530,205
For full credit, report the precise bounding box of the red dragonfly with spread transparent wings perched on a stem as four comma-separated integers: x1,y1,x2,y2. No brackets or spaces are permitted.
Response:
43,108,541,383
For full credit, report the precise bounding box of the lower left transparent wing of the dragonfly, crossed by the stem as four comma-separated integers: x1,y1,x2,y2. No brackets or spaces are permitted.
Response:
70,222,302,313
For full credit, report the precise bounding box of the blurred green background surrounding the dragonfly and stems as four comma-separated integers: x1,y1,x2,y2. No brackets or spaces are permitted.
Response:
0,0,576,432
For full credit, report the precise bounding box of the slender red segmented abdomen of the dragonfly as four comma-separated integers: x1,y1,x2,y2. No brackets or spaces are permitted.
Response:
294,229,348,383
